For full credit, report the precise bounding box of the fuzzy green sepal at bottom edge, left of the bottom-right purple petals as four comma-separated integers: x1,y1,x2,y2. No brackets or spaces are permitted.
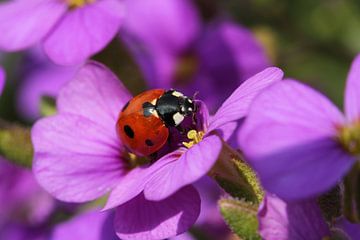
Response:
218,198,261,240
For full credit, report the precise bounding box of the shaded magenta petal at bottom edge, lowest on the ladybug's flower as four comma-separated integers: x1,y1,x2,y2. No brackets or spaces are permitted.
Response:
115,186,200,240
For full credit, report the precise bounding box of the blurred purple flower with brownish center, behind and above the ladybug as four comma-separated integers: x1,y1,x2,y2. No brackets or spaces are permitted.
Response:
121,0,269,112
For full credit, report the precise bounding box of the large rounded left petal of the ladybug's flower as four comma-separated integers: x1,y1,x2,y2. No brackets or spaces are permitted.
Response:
31,114,124,202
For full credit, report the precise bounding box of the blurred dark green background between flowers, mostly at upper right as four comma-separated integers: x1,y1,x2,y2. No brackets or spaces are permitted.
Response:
0,0,360,121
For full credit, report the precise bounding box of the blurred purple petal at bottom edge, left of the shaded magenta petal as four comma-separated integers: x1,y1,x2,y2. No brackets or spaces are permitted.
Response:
51,210,118,240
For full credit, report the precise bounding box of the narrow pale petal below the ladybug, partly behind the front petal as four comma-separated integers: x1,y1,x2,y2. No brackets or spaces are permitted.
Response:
103,152,179,210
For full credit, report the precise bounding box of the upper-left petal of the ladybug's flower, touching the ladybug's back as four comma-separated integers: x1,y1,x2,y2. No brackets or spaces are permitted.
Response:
57,61,131,132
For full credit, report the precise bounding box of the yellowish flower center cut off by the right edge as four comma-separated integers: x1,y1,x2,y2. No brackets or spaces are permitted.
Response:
338,121,360,155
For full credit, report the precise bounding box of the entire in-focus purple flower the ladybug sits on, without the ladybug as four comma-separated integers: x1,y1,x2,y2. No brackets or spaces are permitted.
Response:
32,62,282,239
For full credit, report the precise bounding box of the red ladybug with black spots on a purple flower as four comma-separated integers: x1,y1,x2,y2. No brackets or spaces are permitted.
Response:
116,89,196,156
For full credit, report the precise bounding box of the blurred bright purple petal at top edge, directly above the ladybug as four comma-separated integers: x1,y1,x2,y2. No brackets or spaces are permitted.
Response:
121,0,200,88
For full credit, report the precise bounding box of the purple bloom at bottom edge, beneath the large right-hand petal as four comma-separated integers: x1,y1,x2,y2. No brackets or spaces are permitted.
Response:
258,194,330,240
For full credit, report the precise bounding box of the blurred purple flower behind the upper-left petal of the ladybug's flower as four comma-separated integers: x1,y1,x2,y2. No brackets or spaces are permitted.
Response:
16,48,79,120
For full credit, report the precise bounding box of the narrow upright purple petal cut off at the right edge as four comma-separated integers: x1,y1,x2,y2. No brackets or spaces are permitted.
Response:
345,55,360,121
